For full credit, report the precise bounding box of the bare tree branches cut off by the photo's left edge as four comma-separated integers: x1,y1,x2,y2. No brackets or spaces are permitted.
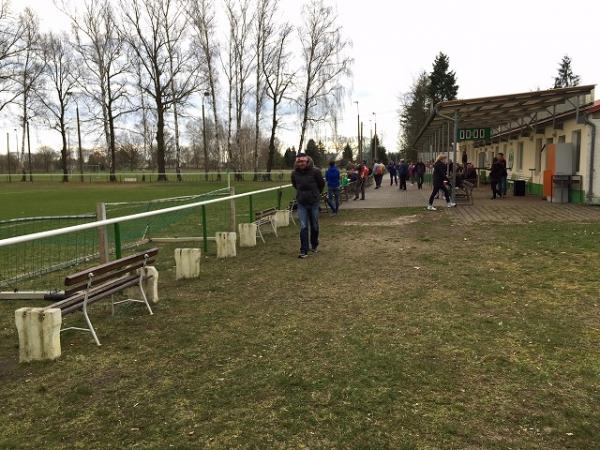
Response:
0,0,23,111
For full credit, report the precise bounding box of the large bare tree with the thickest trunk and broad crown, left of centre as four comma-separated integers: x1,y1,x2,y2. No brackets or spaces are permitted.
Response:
121,0,200,181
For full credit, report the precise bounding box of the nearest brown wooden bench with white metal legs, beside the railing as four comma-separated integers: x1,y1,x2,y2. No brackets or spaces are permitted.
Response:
44,248,158,345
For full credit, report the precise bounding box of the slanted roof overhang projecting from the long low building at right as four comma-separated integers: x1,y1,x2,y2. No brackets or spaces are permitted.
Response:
415,84,595,146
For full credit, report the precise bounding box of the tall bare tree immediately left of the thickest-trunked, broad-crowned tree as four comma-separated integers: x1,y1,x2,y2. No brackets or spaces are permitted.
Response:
70,0,129,181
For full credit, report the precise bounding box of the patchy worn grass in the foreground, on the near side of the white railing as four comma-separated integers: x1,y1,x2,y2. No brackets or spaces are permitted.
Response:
0,209,600,449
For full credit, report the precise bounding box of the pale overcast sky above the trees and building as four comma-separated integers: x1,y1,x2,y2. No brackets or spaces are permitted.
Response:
3,0,600,151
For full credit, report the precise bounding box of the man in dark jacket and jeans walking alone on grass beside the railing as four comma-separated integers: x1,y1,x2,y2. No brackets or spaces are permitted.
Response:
292,153,325,258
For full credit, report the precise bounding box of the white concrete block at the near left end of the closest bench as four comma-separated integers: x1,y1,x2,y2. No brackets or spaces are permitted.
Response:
15,308,62,362
